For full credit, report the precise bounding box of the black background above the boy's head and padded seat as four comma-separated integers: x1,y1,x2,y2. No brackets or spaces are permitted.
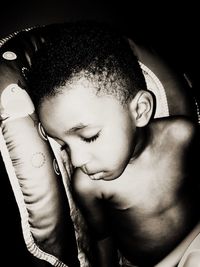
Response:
0,0,200,86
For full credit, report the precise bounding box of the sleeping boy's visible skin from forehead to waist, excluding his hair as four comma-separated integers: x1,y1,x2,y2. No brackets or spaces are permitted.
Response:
39,78,200,267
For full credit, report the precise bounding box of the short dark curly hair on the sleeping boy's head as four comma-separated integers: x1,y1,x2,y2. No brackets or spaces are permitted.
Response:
27,21,146,107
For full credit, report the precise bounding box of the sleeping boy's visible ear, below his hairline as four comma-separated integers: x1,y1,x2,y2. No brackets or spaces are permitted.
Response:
129,90,154,127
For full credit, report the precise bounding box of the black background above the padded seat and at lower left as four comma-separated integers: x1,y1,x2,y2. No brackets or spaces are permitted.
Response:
0,0,200,267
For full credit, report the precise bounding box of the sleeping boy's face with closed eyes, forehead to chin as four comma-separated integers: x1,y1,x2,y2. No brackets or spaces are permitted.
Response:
39,80,136,180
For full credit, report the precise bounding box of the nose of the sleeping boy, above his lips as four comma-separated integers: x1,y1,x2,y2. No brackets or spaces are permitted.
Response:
70,148,90,168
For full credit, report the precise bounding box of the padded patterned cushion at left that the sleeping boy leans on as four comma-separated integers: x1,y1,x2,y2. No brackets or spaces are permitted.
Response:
0,33,80,267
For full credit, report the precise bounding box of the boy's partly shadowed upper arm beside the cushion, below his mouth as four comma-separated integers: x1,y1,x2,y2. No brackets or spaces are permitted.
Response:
72,169,109,239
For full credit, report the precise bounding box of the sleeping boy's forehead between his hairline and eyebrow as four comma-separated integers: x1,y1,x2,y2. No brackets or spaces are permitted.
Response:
39,78,123,136
